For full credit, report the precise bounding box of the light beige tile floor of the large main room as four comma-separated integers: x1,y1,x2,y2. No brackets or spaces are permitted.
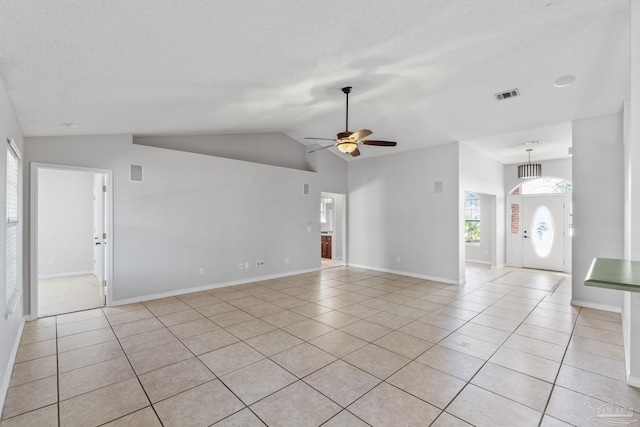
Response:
1,265,640,427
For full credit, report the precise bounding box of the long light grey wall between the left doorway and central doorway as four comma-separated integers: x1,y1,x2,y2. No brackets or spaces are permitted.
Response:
25,135,345,302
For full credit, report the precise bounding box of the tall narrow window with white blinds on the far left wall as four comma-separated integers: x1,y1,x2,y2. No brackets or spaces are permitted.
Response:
5,138,22,316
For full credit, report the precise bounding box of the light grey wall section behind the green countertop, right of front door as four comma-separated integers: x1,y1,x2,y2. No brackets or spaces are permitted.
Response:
572,113,624,310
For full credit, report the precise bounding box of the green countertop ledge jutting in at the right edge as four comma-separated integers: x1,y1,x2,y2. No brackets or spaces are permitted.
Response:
584,258,640,292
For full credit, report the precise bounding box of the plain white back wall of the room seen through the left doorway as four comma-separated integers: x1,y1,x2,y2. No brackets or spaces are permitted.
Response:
38,170,93,278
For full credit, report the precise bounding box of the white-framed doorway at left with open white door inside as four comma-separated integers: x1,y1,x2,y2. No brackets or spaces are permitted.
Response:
31,164,112,319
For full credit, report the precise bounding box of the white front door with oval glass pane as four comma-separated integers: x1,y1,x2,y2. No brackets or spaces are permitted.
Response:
522,196,565,271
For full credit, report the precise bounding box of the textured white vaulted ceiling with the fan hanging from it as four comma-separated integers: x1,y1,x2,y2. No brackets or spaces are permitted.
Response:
0,0,629,161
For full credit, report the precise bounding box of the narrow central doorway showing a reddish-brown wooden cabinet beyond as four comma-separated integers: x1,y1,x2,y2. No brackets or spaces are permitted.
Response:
320,192,347,268
